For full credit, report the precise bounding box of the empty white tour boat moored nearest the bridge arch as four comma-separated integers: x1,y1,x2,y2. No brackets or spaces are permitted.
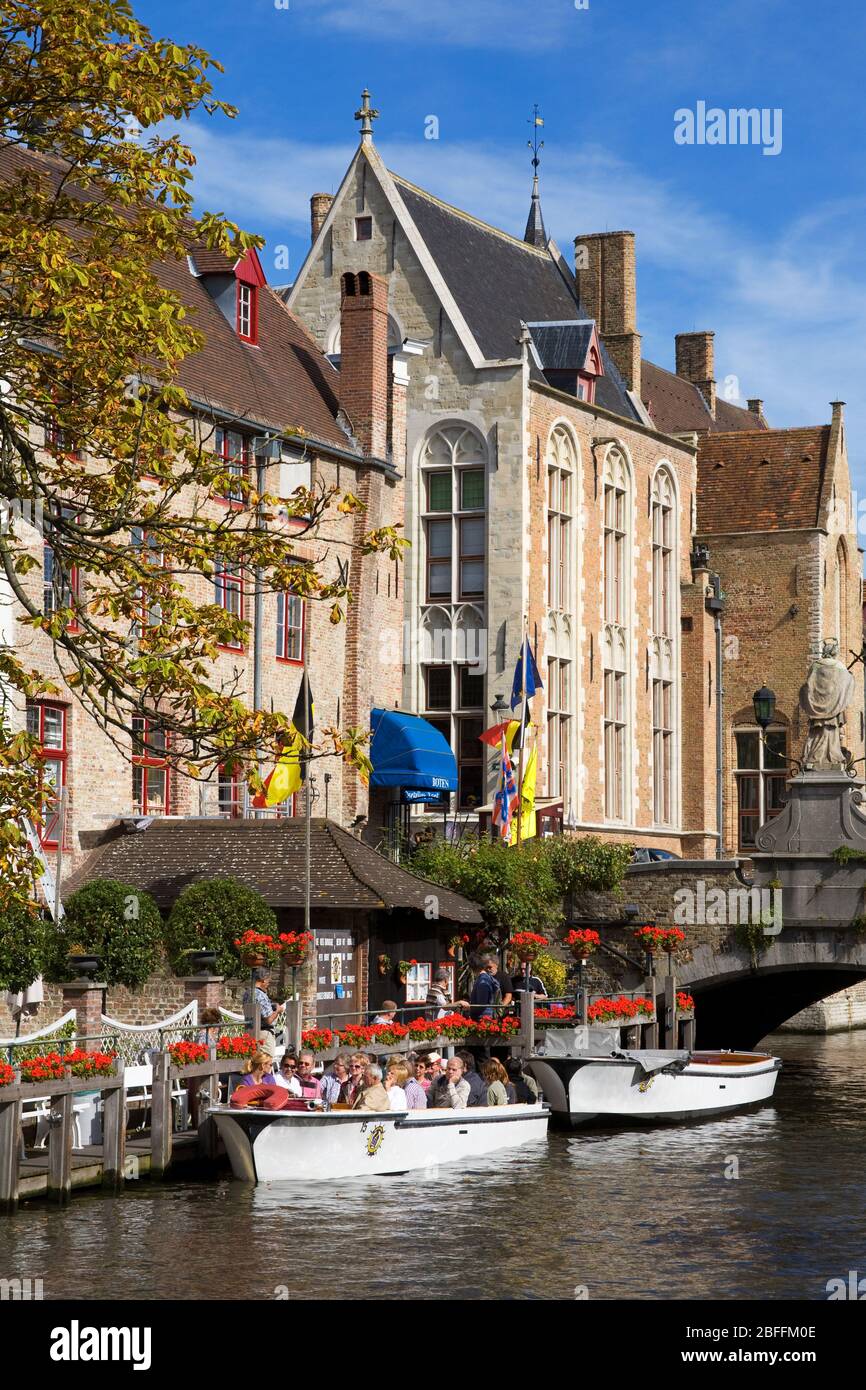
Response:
525,1029,781,1126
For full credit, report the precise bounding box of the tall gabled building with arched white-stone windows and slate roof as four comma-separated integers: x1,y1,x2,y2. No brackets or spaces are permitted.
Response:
285,92,839,858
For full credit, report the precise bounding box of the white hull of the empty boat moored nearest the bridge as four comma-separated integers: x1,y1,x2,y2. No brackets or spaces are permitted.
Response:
527,1054,781,1125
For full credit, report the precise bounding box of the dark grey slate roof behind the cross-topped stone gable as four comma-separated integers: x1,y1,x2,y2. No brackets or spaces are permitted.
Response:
391,174,638,420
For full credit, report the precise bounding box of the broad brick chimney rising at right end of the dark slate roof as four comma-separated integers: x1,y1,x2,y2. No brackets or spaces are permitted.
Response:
574,232,641,396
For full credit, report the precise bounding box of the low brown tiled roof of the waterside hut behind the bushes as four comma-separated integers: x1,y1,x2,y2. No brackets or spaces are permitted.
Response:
65,817,482,923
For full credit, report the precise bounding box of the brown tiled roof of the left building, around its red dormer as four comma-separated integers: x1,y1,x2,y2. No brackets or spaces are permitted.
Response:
0,146,357,453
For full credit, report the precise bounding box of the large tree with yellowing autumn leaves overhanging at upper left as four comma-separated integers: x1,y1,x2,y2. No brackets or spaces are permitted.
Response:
0,0,405,904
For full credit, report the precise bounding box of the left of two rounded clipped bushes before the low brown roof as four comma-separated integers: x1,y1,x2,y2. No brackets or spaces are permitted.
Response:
47,878,163,990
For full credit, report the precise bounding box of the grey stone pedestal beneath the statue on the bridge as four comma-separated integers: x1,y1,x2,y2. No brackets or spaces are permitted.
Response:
751,771,866,927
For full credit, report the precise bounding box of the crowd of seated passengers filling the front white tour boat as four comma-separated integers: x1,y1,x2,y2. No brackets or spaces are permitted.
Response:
242,1051,538,1111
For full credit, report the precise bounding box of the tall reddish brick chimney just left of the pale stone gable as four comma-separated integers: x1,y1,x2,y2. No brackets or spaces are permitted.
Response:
339,270,389,459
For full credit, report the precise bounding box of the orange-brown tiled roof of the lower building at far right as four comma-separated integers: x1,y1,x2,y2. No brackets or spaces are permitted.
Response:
698,425,830,535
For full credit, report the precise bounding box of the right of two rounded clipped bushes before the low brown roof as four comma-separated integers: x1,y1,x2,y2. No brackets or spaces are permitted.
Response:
165,878,278,977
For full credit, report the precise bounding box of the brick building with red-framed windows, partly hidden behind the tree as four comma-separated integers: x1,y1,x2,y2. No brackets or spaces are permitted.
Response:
0,149,407,870
